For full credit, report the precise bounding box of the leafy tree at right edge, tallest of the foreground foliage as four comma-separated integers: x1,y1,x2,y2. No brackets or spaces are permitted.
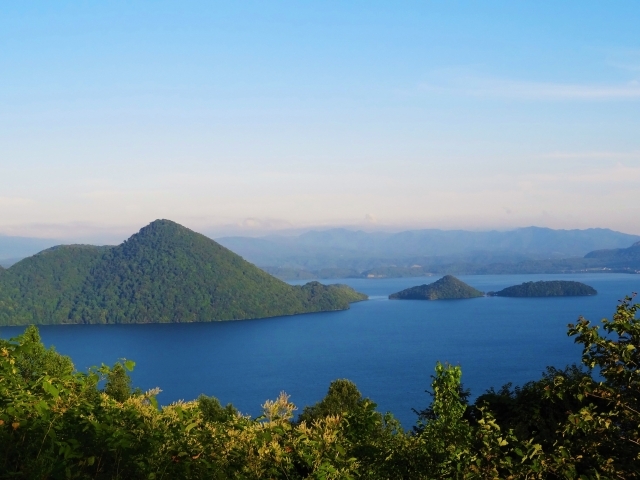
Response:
550,294,640,478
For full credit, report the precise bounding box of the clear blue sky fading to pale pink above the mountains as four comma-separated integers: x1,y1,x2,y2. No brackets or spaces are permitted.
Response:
0,0,640,242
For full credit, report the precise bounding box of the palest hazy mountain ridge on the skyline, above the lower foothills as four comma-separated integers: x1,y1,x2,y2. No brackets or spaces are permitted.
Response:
217,227,640,265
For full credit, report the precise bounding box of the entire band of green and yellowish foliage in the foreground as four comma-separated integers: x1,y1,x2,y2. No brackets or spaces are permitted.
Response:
0,298,640,479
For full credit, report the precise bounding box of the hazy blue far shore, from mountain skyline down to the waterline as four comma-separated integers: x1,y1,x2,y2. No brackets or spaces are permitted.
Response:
218,227,640,279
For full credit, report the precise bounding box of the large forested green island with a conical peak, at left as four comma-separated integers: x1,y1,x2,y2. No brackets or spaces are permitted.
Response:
0,220,366,325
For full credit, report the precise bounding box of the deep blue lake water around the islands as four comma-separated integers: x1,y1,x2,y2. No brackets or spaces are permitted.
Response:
0,274,640,428
